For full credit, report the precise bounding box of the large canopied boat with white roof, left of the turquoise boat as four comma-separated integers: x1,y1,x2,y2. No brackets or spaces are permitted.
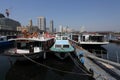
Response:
4,31,54,60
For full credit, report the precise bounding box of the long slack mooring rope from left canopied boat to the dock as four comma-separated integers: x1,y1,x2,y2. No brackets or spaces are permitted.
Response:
23,54,91,76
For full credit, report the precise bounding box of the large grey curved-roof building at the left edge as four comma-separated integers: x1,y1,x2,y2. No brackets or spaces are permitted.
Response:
0,14,21,35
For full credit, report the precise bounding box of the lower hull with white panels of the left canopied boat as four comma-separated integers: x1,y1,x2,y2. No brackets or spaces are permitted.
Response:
4,49,44,61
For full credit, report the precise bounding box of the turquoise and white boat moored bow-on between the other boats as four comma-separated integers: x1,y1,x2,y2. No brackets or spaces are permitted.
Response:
50,34,75,59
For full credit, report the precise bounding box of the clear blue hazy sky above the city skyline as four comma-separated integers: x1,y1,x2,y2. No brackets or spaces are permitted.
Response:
0,0,120,31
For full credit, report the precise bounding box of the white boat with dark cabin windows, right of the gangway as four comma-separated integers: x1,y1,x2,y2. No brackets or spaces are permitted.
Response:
79,34,109,46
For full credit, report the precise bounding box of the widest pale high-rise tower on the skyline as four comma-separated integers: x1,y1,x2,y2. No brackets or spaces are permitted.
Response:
38,16,46,31
